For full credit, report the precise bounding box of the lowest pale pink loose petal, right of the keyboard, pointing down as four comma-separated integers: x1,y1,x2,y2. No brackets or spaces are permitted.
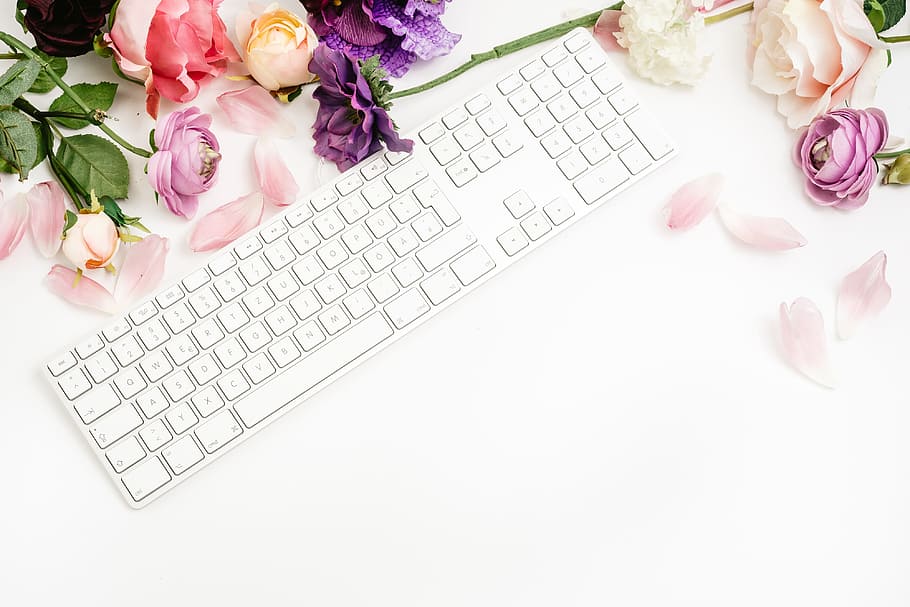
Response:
780,297,834,388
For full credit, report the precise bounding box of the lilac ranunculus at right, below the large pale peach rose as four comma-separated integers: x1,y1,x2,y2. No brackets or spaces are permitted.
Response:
793,108,888,210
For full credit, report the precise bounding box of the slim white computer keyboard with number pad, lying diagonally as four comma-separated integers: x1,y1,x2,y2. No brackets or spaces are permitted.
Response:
45,30,673,508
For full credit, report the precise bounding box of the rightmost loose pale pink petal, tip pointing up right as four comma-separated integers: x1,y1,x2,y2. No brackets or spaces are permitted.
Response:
837,251,891,339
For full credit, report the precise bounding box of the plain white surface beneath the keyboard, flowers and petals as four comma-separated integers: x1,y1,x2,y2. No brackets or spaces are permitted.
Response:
0,0,910,607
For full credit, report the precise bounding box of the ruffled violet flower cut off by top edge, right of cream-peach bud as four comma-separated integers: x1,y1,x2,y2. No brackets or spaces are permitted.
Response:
300,0,461,77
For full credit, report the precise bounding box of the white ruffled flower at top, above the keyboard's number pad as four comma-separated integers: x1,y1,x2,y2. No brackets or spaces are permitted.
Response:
615,0,714,84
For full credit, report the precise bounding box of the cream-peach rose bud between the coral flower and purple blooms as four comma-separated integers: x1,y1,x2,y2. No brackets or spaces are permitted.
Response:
237,3,319,91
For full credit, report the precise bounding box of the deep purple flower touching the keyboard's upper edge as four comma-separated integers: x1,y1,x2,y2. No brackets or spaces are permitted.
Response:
310,44,414,171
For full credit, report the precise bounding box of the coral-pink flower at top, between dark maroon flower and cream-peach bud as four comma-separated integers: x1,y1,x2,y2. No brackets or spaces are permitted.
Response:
105,0,240,118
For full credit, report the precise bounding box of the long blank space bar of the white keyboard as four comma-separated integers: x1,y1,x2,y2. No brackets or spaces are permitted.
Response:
234,314,392,428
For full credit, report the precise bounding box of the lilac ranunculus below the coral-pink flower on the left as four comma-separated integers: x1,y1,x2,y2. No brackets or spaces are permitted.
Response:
148,107,221,219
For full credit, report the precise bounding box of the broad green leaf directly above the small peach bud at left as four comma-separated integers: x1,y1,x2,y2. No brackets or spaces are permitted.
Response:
57,135,130,198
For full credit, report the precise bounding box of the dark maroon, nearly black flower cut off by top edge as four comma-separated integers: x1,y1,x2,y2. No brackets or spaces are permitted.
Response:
25,0,114,57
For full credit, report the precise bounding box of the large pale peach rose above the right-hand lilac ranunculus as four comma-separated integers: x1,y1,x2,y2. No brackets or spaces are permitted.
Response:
750,0,887,128
